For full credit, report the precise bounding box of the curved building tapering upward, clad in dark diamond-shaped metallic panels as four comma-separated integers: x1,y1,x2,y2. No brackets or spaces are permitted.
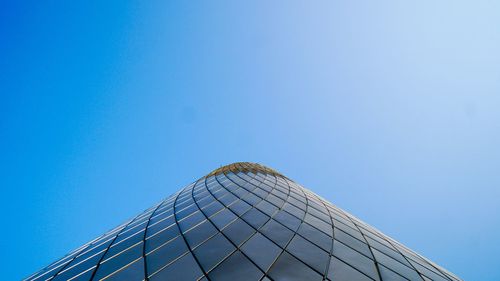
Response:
26,163,460,281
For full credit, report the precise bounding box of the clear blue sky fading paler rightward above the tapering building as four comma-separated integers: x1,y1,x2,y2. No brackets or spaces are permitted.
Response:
0,0,500,280
